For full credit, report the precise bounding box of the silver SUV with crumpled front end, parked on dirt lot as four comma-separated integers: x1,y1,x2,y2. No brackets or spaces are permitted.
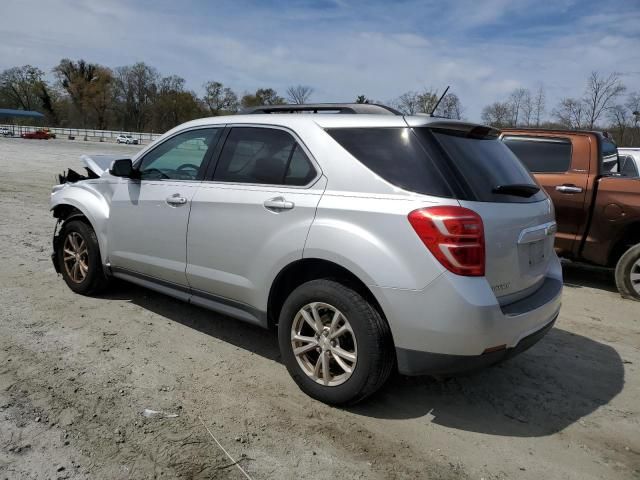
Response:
51,105,562,404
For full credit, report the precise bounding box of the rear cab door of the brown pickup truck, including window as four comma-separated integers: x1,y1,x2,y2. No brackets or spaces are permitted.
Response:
502,134,590,254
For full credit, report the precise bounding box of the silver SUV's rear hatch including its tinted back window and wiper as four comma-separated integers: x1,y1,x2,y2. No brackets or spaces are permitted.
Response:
414,122,555,305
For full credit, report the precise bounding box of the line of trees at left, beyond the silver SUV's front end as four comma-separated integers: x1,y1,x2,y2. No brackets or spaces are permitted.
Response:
0,58,313,132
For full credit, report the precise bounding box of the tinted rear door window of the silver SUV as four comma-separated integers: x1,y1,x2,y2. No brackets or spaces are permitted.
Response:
213,127,316,186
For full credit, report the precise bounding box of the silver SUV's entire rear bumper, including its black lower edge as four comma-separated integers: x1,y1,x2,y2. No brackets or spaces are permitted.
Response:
371,256,562,375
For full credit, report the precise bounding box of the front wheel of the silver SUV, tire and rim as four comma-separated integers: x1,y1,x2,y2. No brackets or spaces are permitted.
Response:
56,220,109,295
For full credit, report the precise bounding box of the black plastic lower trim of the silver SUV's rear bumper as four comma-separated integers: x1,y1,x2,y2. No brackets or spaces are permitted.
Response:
396,317,557,375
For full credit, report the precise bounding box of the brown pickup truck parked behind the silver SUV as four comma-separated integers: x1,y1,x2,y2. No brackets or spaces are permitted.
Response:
502,129,640,301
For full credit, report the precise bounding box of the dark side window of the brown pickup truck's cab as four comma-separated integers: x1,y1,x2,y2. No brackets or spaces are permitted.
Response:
503,137,571,173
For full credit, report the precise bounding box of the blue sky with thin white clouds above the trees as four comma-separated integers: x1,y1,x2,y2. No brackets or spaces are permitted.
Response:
0,0,640,120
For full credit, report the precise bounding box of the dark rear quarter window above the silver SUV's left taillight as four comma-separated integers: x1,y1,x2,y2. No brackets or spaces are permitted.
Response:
327,127,454,197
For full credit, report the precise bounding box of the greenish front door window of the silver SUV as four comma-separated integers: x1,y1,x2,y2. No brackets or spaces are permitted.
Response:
139,128,222,180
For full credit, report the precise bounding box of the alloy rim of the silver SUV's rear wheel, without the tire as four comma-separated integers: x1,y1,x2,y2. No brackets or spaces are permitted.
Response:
291,302,358,387
